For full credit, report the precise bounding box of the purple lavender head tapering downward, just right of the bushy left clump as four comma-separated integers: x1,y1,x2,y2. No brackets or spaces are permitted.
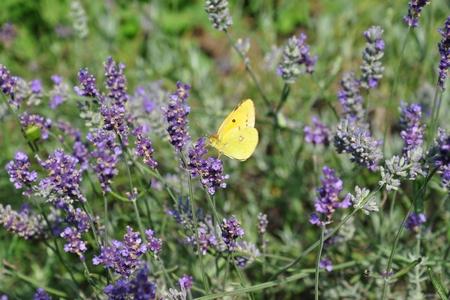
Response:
87,129,122,192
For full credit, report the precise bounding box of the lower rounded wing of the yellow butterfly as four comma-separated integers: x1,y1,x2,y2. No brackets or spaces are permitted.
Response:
215,128,259,161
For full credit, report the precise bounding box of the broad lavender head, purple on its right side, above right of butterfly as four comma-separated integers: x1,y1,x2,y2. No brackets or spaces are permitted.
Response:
277,33,317,83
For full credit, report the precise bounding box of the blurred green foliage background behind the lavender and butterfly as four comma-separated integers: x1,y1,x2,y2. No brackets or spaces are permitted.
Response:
0,0,450,299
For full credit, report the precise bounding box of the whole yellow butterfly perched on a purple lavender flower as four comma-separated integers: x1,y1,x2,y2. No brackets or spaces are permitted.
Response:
209,99,258,161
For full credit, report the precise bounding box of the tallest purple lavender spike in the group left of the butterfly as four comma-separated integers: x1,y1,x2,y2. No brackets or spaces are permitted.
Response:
104,57,128,106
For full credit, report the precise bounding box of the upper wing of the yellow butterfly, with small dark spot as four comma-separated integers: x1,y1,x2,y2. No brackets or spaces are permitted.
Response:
217,99,255,140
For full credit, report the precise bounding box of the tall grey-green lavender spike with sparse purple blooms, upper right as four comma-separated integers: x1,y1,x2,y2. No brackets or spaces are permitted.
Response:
361,26,384,89
